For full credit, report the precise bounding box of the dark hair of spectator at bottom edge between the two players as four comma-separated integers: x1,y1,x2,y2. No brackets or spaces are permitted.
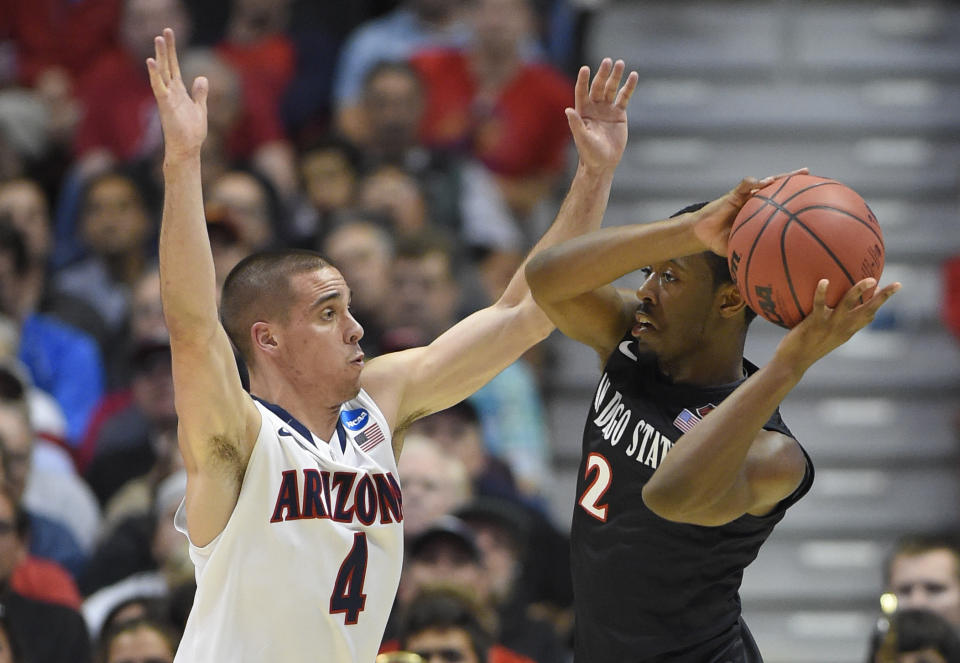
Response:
399,587,493,661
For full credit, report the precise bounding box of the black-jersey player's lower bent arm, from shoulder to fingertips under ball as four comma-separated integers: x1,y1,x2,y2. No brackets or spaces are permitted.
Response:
643,279,900,525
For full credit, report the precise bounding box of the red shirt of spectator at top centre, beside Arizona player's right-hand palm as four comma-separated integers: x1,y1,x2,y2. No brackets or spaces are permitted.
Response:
411,49,573,177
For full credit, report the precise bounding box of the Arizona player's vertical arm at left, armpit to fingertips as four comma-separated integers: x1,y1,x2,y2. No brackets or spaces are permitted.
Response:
147,29,260,545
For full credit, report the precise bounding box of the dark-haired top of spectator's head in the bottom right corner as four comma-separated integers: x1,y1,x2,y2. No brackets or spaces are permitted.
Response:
867,610,960,663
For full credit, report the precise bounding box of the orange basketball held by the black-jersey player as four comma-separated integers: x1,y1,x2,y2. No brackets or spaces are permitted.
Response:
727,175,885,328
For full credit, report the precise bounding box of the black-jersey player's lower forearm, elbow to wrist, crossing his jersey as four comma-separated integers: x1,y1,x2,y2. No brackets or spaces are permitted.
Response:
643,356,803,516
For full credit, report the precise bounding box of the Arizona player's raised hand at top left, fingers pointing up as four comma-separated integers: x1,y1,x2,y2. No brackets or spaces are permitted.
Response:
147,28,209,161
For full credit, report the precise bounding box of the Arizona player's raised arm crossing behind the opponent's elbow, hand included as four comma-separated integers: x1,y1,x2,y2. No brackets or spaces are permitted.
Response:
363,59,637,452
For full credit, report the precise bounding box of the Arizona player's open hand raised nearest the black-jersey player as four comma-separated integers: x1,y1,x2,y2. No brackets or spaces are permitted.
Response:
566,58,639,172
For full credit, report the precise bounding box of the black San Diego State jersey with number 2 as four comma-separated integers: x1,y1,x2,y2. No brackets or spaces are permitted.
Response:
571,334,813,663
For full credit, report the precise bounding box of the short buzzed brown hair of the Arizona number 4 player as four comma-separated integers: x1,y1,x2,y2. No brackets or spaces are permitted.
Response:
220,249,332,366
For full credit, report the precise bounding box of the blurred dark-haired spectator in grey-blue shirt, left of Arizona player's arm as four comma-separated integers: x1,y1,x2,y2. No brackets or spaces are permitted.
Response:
53,171,156,358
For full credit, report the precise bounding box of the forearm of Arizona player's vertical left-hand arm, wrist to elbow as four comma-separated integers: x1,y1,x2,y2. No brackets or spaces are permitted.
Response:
160,155,219,337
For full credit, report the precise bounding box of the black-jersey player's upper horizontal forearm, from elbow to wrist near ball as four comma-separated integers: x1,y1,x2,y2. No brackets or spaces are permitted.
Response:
526,208,707,302
